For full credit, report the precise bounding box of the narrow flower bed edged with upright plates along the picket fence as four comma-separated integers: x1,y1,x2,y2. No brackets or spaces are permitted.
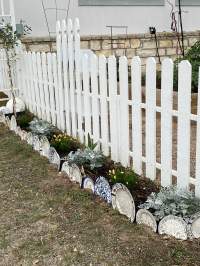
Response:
0,110,200,240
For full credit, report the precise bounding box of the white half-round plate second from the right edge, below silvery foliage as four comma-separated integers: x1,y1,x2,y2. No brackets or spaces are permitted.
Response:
158,215,187,240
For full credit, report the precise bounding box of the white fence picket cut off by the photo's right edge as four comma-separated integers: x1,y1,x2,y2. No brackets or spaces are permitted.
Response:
195,68,200,198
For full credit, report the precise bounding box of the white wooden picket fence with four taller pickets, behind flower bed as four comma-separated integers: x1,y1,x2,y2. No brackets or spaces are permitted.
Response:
1,19,200,197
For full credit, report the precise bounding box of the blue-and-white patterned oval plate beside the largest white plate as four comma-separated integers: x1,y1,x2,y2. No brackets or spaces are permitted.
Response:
94,176,112,204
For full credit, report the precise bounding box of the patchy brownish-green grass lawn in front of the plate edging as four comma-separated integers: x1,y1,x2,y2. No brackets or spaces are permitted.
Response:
0,125,200,266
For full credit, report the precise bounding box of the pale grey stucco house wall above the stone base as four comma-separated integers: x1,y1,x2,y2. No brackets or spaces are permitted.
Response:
14,0,200,36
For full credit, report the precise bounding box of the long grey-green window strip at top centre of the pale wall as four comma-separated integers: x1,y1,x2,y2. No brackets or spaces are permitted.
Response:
79,0,165,6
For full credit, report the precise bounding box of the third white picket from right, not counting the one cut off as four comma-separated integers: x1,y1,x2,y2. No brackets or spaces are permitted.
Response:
145,58,156,180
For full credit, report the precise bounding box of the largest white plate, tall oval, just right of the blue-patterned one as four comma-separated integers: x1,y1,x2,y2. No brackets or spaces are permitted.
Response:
112,183,135,222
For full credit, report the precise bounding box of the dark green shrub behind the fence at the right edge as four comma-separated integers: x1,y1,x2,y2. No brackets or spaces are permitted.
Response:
174,41,200,92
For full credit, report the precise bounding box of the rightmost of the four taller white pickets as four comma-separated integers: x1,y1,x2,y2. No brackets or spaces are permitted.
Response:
74,18,84,142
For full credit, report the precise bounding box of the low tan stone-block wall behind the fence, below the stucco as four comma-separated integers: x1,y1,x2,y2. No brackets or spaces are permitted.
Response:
20,31,200,64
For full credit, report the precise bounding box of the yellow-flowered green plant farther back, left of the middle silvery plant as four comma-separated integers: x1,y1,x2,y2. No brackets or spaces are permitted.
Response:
51,134,81,154
